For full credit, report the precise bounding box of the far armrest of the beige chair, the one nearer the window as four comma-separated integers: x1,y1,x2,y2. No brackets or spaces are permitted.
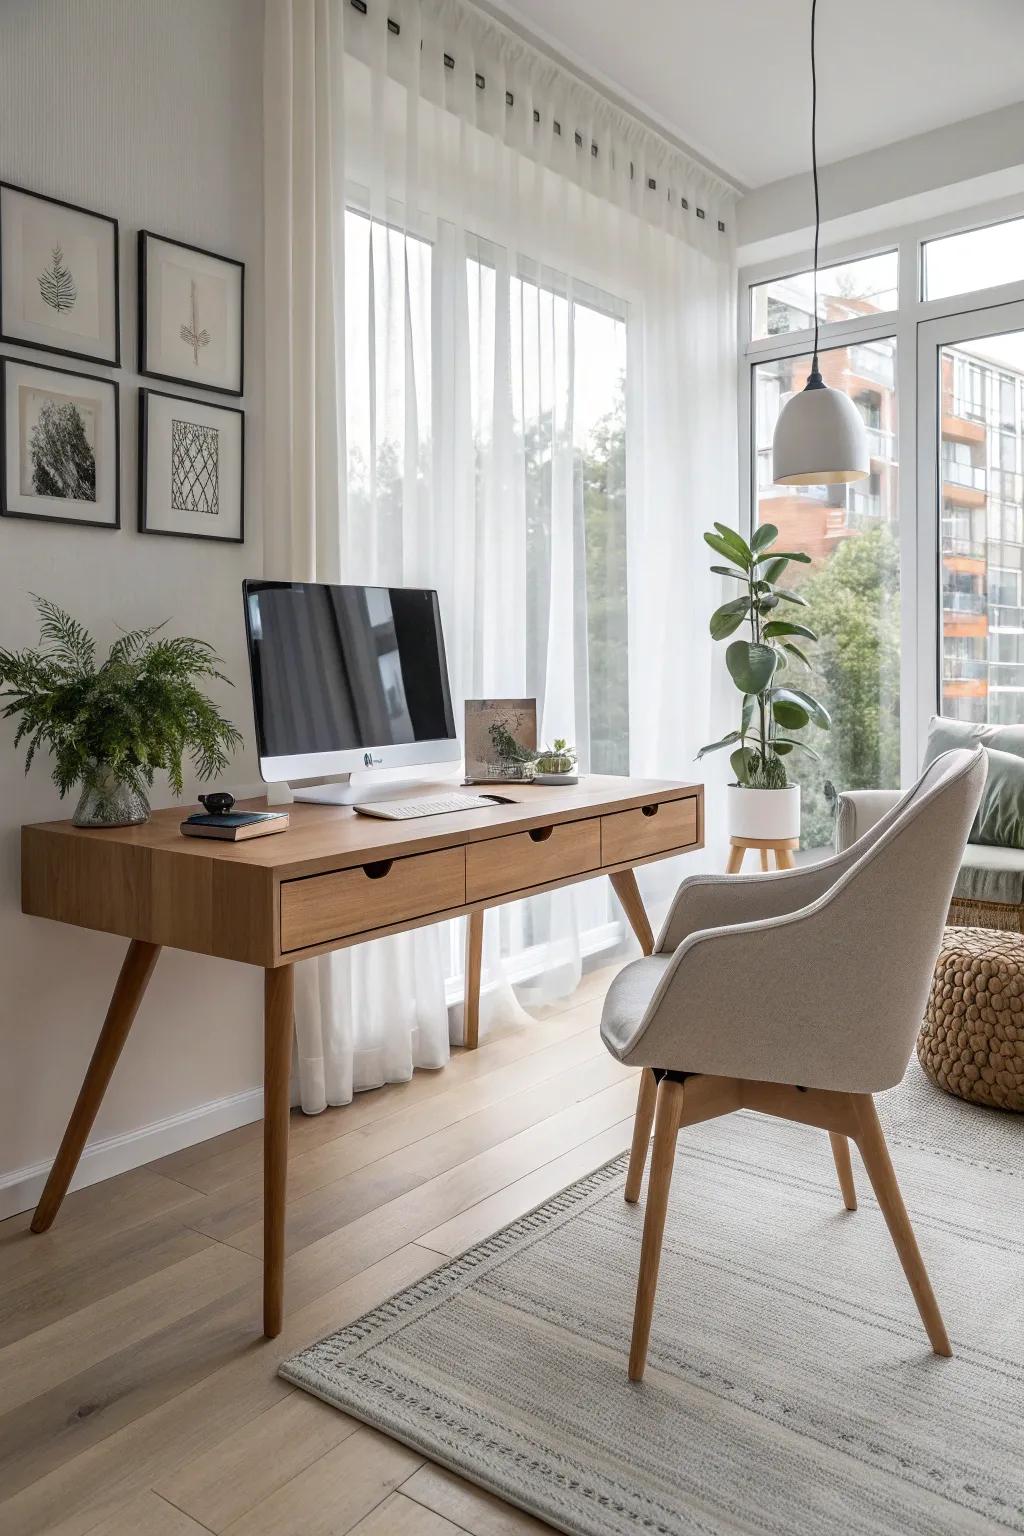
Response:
654,854,851,954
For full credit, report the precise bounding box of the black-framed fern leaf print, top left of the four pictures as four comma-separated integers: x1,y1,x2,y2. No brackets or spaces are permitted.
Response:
0,181,121,369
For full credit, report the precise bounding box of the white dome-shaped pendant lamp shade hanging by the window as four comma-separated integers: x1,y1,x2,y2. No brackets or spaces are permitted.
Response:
772,384,870,485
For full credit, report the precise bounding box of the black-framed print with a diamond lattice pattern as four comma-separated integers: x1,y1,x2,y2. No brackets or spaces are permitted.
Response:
138,389,246,544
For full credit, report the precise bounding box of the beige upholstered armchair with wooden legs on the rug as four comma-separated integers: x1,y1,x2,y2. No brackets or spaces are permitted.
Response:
600,748,986,1381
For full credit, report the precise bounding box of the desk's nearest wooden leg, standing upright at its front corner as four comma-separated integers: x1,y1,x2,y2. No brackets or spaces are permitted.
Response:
263,965,295,1339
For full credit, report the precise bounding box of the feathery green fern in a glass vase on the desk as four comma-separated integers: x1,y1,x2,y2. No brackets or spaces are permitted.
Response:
0,598,241,826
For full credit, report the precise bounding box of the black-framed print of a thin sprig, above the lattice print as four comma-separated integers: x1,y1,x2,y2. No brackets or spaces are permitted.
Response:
138,229,246,398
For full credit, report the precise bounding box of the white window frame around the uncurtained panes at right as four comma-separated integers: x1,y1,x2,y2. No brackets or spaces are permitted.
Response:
737,192,1024,785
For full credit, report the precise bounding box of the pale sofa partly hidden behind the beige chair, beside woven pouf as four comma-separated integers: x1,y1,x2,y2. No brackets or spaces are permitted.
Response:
835,716,1024,934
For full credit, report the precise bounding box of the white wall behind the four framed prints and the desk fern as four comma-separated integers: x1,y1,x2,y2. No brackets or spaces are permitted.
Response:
0,0,263,1215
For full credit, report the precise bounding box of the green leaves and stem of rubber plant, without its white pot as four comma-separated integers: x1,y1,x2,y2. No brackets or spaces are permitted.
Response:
697,522,832,790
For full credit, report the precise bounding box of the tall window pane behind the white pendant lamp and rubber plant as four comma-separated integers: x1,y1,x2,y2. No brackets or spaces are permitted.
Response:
751,338,900,848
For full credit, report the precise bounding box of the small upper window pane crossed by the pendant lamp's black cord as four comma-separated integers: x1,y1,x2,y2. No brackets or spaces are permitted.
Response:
751,250,898,341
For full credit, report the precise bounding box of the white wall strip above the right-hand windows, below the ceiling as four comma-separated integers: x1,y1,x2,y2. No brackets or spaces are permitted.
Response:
737,97,1024,266
